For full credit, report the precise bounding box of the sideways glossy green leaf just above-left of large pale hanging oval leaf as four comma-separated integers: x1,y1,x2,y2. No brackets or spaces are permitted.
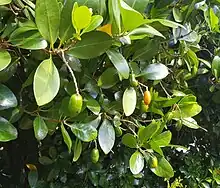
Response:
9,27,47,50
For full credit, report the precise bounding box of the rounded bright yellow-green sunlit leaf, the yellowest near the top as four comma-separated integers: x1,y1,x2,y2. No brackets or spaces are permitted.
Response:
72,6,92,32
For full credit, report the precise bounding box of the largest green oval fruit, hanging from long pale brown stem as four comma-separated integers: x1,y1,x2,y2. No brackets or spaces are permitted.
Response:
68,94,83,117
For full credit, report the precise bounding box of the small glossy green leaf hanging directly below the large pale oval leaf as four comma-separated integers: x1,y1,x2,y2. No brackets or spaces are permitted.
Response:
33,116,48,140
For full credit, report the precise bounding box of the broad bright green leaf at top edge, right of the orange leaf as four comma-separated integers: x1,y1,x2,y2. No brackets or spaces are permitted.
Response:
120,0,146,31
